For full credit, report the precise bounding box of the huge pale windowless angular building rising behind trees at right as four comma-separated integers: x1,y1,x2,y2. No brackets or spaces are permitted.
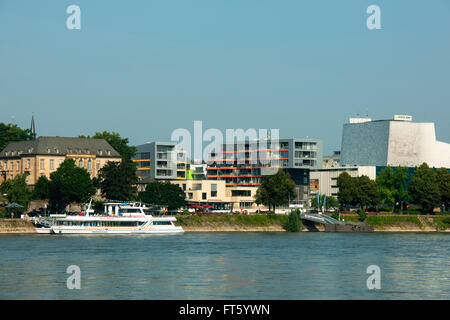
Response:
341,115,450,168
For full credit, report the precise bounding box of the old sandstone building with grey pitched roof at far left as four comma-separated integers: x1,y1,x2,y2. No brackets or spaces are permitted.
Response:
0,137,121,185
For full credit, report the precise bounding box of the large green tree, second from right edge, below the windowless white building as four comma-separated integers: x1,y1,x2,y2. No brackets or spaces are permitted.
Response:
408,163,441,212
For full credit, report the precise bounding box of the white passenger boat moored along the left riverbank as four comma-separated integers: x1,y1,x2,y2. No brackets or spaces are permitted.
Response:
36,202,184,234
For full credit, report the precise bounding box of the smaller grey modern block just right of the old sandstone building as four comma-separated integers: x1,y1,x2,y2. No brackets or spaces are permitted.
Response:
133,142,187,180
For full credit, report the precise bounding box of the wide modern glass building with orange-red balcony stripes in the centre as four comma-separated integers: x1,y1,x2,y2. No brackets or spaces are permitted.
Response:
207,138,322,201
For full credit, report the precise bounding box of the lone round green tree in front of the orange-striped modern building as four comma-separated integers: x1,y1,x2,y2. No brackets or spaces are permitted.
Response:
255,169,295,210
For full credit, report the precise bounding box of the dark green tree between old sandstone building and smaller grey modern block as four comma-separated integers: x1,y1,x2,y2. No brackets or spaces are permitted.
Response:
98,161,137,200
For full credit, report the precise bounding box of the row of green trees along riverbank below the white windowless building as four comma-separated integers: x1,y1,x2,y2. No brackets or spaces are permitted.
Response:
337,163,450,212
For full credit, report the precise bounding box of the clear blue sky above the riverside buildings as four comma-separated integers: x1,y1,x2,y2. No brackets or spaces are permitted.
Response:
0,0,450,154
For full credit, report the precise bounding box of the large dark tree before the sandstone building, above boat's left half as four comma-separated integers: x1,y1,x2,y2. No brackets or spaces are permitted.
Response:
49,159,96,212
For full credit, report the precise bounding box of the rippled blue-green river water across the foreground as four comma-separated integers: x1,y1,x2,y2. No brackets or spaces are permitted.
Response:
0,232,450,299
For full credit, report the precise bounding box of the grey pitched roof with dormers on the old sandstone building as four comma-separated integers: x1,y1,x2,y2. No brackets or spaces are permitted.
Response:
0,137,120,158
